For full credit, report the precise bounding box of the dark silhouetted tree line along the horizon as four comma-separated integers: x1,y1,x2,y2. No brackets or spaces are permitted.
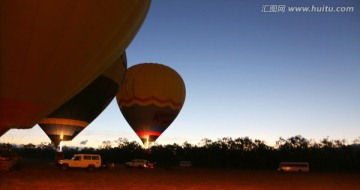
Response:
0,135,360,171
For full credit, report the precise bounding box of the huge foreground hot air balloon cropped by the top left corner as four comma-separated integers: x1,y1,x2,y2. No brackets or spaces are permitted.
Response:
0,0,150,133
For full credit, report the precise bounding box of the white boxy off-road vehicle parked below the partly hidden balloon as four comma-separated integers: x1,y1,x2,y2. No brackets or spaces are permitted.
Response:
57,154,101,171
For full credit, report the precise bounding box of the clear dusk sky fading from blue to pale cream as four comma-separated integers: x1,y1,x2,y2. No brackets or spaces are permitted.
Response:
0,0,360,148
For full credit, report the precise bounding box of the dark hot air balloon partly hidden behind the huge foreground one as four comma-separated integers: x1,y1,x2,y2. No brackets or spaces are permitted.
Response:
38,53,127,147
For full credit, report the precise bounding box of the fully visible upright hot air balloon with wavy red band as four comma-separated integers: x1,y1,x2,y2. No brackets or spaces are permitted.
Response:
116,63,186,148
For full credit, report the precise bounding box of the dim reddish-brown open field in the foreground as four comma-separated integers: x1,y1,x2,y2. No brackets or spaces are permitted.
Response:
0,162,360,190
